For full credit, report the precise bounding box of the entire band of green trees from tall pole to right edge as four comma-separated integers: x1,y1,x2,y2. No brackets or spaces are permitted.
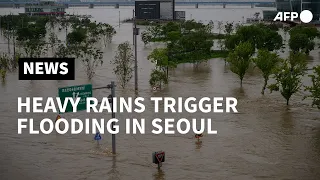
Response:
135,21,320,108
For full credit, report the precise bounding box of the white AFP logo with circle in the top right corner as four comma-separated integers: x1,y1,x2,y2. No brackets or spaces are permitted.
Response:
273,10,313,23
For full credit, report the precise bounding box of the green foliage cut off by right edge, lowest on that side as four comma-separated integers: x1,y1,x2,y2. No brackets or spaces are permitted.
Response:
305,66,320,109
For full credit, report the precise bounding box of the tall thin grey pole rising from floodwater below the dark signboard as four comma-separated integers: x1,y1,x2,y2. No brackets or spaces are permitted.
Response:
133,10,139,92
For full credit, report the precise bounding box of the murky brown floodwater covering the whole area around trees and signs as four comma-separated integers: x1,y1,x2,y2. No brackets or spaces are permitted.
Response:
0,7,320,180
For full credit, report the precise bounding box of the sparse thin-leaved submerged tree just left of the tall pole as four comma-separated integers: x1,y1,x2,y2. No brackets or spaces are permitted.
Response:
112,42,134,88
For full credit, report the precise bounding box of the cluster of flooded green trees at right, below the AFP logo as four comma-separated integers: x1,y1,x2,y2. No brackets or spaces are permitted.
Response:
225,24,320,108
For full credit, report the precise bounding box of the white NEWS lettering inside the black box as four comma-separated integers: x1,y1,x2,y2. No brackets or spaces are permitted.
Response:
23,62,68,75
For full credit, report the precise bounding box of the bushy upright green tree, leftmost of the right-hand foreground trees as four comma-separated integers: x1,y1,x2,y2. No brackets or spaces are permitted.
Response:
227,42,254,86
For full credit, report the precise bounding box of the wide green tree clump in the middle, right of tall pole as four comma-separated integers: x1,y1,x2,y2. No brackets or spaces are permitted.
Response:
142,20,226,86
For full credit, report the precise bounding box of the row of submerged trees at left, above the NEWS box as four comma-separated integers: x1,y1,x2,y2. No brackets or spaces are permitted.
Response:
0,15,116,79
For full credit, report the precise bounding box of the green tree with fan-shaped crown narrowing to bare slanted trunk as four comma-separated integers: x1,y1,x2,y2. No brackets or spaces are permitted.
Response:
252,50,281,94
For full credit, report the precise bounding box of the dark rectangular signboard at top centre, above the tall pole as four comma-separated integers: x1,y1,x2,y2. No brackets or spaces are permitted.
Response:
135,1,160,19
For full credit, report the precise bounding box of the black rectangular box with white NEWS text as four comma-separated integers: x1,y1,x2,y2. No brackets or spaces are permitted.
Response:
19,58,75,80
